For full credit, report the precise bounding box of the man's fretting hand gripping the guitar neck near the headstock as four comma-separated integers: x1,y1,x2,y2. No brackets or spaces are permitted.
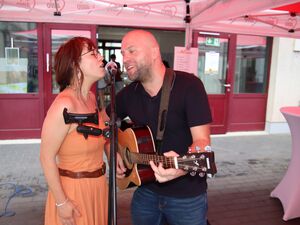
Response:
150,151,187,183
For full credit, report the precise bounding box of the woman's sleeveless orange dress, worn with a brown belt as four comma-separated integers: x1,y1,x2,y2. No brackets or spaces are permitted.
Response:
45,118,108,225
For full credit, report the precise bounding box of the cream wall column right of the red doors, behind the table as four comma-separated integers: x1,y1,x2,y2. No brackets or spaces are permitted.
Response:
265,38,300,133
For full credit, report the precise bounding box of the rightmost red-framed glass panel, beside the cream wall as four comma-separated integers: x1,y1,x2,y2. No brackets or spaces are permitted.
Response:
228,34,272,131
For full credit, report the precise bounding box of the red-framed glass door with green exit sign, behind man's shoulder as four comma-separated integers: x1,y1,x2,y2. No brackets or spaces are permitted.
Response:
193,32,232,134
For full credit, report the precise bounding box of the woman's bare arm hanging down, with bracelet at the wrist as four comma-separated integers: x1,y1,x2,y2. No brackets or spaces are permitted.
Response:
40,98,80,224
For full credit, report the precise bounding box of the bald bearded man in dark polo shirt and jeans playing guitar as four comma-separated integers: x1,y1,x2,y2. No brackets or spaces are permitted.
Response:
107,30,211,225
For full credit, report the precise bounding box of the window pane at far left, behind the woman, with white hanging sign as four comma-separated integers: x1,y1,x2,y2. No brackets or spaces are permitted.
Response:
0,22,38,94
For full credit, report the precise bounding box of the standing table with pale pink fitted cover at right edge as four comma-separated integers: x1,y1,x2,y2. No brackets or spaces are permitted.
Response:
271,106,300,221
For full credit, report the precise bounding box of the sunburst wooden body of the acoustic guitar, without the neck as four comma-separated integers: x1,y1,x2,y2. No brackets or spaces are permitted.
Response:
117,126,156,189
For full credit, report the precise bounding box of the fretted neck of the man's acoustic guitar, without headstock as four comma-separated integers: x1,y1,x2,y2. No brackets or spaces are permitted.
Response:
129,152,176,168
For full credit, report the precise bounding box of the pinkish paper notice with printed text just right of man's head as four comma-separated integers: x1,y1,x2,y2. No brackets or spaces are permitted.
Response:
174,46,198,76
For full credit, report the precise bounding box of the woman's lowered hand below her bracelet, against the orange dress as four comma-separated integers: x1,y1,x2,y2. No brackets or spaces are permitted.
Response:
57,200,81,225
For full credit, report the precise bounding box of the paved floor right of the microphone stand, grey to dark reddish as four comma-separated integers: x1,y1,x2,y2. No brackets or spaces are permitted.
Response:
117,135,300,225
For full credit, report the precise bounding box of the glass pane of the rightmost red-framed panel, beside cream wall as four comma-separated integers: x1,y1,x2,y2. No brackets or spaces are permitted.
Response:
234,35,270,93
